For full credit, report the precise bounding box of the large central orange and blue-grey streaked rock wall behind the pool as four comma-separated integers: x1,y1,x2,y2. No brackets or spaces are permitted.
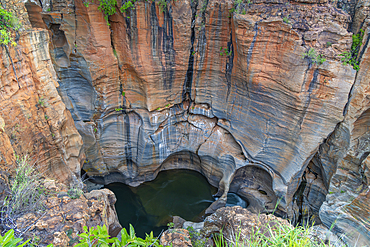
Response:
23,0,366,219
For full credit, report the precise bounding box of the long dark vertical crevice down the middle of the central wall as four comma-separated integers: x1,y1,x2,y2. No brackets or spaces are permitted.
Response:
182,1,198,101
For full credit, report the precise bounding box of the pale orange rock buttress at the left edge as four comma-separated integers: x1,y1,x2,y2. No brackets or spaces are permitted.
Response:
0,30,84,183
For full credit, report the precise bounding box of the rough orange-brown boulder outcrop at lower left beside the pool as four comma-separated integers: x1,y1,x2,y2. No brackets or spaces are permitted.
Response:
16,179,122,247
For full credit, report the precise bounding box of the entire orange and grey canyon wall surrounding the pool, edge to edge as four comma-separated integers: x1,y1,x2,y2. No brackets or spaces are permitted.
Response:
0,0,370,243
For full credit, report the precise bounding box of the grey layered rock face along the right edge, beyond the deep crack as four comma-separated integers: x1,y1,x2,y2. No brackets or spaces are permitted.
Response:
318,15,370,246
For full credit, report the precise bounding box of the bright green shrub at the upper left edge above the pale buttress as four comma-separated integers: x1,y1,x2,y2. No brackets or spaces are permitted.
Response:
0,6,20,46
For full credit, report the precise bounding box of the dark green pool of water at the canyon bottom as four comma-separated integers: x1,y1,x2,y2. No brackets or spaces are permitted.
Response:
105,170,217,237
